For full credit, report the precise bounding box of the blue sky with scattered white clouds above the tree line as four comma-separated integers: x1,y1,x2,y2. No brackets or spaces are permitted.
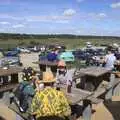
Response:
0,0,120,36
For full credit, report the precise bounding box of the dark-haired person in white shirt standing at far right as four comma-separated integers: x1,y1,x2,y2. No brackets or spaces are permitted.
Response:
104,50,116,70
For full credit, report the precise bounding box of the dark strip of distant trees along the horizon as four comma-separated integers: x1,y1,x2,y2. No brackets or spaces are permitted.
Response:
0,33,120,40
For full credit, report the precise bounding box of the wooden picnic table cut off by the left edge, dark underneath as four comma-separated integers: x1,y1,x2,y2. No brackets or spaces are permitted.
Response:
0,66,23,93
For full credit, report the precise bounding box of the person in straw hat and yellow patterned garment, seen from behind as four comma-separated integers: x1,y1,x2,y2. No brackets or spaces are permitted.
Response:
31,72,71,120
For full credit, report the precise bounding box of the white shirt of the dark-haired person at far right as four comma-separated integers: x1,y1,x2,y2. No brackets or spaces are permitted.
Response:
105,54,116,69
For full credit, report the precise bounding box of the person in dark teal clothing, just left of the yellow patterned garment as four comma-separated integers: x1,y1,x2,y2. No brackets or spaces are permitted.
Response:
11,76,35,113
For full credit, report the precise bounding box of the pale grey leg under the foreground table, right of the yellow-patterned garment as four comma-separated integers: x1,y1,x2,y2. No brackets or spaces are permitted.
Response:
82,100,92,120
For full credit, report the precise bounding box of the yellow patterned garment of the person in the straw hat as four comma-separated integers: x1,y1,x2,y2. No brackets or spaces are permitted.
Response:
31,88,71,118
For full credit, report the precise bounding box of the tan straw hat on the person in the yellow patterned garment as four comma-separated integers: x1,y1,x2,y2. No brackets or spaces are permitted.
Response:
40,71,56,83
